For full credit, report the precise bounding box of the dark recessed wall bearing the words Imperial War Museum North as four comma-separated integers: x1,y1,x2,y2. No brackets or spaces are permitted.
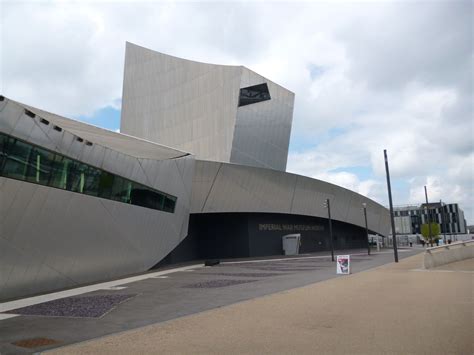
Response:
155,213,367,267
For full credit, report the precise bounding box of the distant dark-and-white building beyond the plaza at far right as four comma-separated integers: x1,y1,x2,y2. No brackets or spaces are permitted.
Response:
394,202,467,235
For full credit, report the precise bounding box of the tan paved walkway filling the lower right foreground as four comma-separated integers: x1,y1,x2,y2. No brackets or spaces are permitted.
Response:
48,254,474,354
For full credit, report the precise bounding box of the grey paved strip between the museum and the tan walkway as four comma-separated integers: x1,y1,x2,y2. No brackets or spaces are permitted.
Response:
0,249,421,354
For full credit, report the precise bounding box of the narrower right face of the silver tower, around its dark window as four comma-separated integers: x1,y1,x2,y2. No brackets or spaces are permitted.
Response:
230,67,295,171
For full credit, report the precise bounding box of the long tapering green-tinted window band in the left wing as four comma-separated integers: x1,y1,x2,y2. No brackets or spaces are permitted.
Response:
0,133,177,213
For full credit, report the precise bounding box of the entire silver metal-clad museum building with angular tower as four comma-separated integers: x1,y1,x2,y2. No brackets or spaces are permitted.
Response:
0,43,390,300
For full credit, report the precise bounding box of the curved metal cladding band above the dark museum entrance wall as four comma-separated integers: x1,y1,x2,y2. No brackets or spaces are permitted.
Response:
191,160,390,236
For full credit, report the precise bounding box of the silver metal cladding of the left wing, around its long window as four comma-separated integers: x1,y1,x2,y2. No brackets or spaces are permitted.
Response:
0,98,194,300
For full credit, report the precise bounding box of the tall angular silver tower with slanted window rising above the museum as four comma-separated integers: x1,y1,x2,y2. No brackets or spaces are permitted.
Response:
120,43,295,171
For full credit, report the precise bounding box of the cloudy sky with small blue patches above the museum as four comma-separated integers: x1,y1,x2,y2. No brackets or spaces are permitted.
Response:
0,0,474,224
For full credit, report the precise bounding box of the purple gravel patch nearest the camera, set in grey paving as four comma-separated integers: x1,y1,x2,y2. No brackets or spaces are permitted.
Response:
5,294,136,318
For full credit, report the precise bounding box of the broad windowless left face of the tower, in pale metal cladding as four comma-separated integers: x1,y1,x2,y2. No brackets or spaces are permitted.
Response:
121,42,242,161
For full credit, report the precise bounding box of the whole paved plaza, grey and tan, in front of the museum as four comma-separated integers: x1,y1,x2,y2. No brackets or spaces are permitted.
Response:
0,249,473,354
